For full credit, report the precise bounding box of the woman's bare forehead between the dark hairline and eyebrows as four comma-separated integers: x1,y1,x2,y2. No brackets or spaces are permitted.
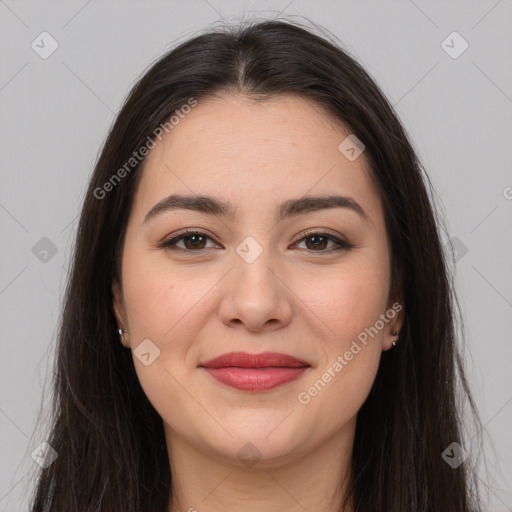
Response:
134,95,382,228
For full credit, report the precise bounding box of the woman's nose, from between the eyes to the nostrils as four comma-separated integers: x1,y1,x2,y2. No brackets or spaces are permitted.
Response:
219,246,293,332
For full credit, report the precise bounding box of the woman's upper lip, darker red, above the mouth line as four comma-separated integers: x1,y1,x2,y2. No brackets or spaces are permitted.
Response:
199,352,310,368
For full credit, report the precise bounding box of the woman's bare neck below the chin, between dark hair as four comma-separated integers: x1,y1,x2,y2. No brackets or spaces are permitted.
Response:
164,418,355,512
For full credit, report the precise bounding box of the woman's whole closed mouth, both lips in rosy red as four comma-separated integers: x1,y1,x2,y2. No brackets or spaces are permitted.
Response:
199,352,311,391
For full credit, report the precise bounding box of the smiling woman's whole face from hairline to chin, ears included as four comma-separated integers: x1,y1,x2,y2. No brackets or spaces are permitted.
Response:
113,95,402,464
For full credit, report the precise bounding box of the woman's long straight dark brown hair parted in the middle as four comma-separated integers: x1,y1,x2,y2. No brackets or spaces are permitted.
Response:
31,17,479,512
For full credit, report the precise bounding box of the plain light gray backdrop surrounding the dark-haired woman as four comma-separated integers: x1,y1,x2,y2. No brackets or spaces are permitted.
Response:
0,0,512,512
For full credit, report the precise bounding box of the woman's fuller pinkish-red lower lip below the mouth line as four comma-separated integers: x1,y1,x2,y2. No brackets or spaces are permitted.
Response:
205,366,309,391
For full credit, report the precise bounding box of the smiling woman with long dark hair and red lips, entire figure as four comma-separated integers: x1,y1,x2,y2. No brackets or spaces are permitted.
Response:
31,21,479,512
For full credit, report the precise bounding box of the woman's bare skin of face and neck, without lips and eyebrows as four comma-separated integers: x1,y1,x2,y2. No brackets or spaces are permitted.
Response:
112,95,403,512
